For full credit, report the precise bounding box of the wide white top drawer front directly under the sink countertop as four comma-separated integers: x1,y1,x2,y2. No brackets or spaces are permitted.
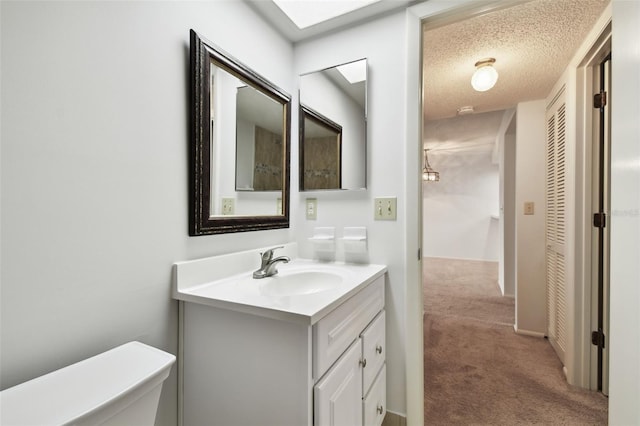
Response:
313,275,384,381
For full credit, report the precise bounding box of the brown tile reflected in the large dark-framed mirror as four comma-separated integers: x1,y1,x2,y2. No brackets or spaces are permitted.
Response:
253,126,283,191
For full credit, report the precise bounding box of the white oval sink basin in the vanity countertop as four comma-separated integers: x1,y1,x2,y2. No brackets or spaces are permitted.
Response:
261,270,343,296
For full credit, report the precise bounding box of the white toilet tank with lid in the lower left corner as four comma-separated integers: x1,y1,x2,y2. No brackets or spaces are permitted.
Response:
0,342,176,426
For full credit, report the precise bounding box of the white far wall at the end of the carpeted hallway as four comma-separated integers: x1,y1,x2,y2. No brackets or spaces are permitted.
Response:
423,146,500,261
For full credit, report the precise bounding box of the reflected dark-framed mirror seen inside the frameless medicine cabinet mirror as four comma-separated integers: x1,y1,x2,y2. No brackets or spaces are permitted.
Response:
299,105,342,191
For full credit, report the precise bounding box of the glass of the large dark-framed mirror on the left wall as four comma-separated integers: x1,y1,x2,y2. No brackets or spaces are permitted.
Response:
209,60,285,217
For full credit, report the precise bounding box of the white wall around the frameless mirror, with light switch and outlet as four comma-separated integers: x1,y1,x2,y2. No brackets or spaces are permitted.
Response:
291,13,418,415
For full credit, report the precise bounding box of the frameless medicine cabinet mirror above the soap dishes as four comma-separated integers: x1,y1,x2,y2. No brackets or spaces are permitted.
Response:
299,59,367,191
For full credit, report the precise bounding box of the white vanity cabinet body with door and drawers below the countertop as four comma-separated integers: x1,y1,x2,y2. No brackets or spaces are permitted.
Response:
179,266,386,426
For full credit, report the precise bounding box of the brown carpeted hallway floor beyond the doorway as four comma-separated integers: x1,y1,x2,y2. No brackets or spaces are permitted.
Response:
423,258,607,425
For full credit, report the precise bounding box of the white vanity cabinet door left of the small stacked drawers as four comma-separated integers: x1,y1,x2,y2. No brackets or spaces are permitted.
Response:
313,339,362,426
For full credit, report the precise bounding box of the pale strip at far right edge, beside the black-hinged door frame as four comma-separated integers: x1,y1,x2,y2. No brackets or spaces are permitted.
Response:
609,0,640,425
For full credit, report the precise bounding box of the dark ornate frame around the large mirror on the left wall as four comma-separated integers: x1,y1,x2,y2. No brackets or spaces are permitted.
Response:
189,30,291,236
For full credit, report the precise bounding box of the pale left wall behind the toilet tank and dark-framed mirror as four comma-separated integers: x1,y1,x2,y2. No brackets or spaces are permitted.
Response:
0,1,294,425
